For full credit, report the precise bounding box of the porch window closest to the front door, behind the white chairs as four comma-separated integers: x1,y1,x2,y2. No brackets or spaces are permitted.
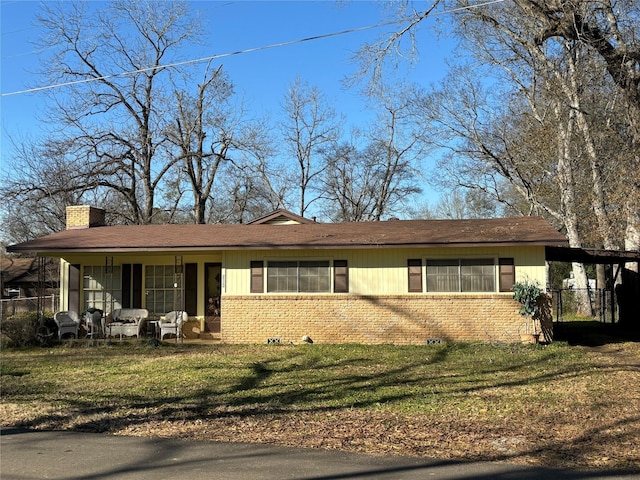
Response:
144,265,184,315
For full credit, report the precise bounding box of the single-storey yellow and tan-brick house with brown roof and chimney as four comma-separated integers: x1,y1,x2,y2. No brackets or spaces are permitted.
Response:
8,206,568,344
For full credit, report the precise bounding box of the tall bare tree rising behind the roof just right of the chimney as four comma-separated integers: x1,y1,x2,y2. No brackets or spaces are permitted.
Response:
32,0,197,223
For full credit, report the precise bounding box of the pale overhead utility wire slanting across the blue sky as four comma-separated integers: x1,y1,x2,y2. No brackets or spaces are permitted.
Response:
0,0,505,97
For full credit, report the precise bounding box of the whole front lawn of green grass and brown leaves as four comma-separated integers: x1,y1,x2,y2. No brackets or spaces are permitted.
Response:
0,342,640,469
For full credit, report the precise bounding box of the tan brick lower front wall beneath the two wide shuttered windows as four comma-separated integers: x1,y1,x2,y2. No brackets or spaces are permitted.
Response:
222,294,524,345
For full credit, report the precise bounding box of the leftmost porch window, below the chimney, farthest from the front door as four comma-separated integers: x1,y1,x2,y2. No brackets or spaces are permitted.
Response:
82,265,122,313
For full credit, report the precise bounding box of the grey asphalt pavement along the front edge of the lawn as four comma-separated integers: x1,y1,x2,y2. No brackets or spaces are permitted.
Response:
0,428,640,480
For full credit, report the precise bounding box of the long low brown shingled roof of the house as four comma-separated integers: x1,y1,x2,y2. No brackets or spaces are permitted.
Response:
7,217,568,254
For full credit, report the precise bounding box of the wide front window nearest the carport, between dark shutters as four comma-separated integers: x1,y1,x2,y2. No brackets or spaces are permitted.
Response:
427,258,495,292
